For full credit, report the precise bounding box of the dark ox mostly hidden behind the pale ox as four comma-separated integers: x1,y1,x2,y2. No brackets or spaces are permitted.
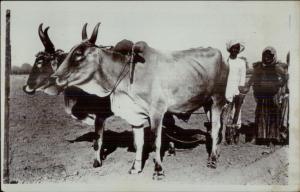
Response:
23,24,180,167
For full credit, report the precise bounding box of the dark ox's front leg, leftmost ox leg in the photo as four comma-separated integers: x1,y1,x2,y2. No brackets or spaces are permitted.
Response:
93,116,105,168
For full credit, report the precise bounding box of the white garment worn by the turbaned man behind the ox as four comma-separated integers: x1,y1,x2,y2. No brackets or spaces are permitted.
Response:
226,58,246,128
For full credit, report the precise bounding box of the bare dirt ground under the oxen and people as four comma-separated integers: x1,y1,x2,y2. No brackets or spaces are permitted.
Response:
9,76,289,185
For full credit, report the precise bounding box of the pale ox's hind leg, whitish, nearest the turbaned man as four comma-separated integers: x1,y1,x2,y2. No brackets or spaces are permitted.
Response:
207,104,222,168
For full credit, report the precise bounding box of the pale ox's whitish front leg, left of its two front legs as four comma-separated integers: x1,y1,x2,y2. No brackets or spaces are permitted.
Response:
129,127,144,174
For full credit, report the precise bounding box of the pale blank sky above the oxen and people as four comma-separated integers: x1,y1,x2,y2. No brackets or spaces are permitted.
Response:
1,1,299,66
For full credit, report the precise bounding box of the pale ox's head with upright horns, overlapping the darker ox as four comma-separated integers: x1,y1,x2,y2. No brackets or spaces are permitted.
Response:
52,23,101,87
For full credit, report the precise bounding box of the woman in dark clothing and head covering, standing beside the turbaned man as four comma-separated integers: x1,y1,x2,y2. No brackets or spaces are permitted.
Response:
249,47,288,145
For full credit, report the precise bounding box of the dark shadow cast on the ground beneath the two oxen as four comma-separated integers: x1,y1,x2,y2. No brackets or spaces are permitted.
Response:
68,125,208,164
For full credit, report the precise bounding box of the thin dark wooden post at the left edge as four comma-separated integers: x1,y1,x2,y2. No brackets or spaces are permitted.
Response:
3,10,11,183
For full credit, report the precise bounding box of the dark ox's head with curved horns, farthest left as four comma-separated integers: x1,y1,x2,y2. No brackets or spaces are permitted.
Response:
23,24,65,95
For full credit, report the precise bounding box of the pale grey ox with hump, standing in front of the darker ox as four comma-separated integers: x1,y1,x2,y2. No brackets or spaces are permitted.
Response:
53,23,227,179
